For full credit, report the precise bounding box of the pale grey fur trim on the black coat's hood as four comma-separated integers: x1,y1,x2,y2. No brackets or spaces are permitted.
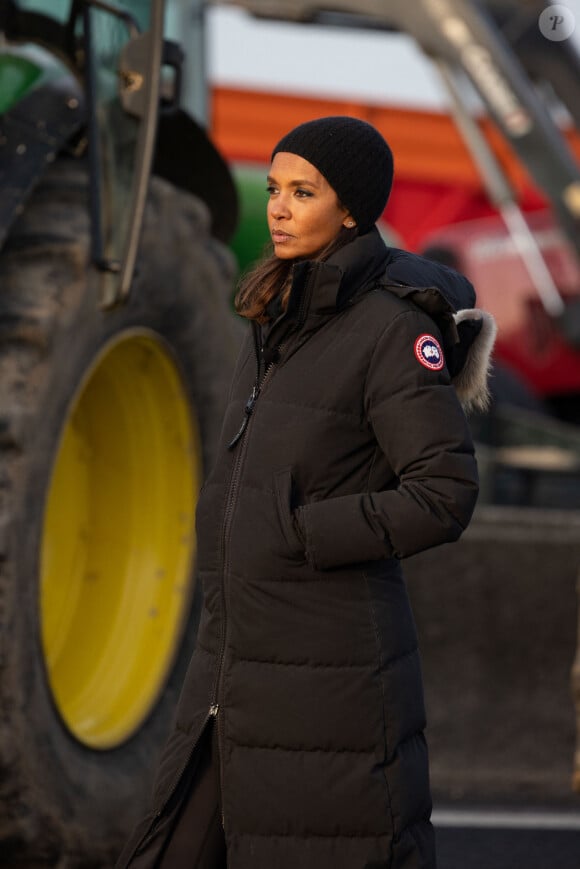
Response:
452,308,497,413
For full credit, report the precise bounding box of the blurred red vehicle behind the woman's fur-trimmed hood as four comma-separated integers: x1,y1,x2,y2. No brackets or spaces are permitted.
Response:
424,210,580,421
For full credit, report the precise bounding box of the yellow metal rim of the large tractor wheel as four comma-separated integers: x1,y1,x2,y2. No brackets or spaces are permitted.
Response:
40,331,201,749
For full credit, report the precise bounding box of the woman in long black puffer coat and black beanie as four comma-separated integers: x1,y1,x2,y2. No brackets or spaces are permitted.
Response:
118,117,493,869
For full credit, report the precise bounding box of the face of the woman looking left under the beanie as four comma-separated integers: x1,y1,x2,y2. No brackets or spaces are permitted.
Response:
267,151,354,259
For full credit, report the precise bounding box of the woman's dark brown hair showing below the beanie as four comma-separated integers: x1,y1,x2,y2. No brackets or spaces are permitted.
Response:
234,226,358,323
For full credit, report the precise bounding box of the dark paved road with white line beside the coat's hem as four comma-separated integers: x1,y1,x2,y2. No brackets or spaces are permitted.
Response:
433,808,580,869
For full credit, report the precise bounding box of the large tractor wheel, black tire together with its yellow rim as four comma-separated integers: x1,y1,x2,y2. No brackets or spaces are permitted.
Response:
0,159,238,869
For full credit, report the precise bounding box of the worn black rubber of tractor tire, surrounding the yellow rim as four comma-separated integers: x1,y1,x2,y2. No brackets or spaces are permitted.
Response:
0,159,238,869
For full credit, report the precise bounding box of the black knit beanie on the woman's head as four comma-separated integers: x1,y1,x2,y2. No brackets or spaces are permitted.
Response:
272,116,393,235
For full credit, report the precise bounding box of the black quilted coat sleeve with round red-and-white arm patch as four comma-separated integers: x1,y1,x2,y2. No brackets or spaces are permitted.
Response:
297,310,478,569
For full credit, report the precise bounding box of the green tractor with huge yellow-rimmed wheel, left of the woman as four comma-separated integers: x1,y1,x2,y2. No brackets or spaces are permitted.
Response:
0,0,238,869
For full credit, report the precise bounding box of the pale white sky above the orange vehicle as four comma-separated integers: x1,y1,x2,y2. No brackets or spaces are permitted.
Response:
208,0,580,109
